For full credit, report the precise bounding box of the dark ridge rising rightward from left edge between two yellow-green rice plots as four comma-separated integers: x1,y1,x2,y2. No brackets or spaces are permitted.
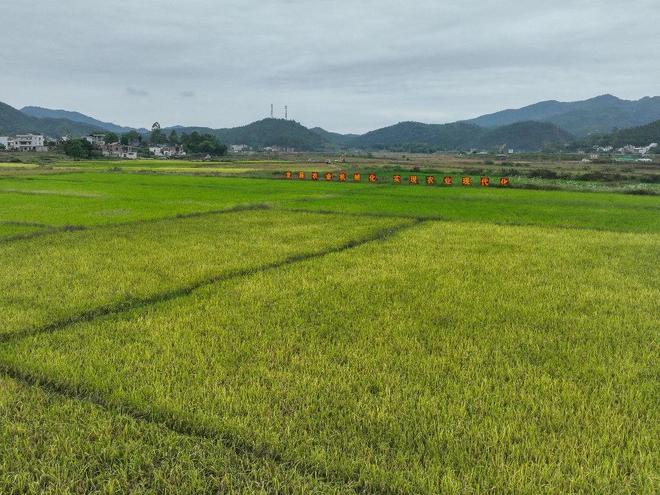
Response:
0,219,425,344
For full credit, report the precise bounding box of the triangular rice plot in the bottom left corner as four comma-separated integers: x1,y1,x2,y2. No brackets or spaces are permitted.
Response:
0,377,347,495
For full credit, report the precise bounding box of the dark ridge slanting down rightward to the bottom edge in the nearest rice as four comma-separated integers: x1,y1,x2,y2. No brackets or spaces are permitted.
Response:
0,362,392,495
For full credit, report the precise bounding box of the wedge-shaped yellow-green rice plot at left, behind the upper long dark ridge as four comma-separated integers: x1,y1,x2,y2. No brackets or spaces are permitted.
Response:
0,210,410,341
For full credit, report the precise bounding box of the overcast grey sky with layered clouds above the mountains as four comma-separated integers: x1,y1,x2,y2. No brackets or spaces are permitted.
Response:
0,0,660,132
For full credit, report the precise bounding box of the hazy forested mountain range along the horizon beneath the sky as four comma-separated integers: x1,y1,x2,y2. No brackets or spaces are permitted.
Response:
0,95,660,152
